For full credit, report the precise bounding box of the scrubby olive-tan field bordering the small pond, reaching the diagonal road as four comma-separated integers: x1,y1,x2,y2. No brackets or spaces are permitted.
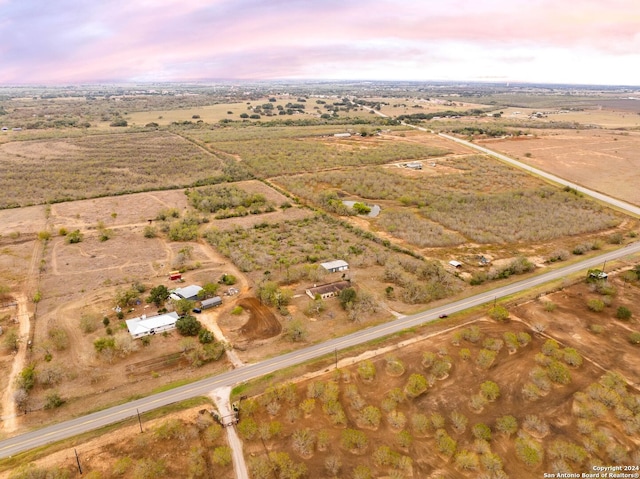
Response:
274,155,620,247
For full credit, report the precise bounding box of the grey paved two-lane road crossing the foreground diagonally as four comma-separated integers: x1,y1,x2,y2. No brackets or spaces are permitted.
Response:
0,242,640,457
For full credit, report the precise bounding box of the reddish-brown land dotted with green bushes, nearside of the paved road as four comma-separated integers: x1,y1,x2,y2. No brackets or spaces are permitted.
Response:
9,265,640,479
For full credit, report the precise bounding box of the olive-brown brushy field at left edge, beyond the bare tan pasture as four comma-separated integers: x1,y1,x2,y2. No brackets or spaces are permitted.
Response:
0,132,252,208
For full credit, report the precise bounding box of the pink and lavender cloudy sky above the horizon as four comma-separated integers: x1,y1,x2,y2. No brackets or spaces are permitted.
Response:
0,0,640,85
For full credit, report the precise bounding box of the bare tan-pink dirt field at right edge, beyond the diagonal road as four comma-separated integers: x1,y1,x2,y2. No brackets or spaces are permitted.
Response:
479,130,640,205
